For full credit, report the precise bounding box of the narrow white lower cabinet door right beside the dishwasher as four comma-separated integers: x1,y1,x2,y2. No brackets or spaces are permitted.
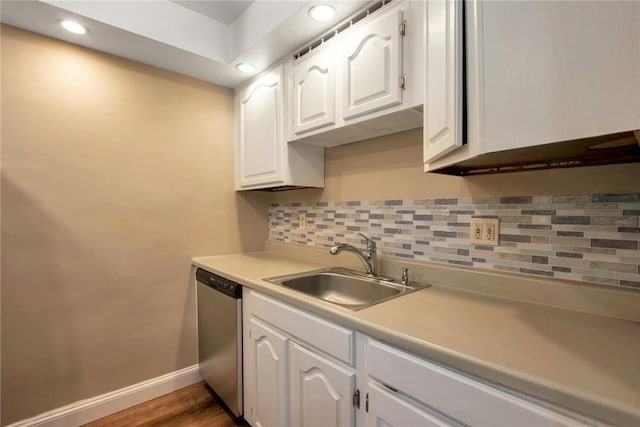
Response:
244,316,288,427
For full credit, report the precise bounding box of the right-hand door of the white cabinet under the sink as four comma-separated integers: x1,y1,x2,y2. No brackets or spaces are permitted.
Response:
290,344,356,427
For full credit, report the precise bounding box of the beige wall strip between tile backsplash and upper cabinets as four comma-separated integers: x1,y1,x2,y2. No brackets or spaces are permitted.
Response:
272,129,640,206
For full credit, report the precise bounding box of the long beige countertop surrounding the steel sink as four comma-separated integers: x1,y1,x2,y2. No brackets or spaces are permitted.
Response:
193,252,640,426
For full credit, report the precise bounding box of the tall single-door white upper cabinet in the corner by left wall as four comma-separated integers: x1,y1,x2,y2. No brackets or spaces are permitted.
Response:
235,65,324,190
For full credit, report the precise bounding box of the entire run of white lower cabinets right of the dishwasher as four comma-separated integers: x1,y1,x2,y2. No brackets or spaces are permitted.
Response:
243,290,605,427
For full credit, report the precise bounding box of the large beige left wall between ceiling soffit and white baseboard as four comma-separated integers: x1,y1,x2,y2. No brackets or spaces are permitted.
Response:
1,26,267,424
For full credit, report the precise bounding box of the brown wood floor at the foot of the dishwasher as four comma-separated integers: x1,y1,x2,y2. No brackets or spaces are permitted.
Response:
85,381,248,427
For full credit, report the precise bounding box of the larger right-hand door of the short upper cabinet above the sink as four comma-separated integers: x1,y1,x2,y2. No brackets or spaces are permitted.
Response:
342,5,403,119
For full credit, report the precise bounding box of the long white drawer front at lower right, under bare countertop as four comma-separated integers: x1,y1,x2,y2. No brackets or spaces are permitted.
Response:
367,340,590,427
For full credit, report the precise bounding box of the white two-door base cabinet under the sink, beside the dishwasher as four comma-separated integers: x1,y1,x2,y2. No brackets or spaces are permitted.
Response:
243,290,356,427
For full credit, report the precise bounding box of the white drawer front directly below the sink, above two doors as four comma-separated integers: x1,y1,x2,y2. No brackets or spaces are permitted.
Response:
244,291,354,365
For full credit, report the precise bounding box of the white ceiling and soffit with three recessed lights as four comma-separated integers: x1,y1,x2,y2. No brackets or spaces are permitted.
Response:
0,0,370,87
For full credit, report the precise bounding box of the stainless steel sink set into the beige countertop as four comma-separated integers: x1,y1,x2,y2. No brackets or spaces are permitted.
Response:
264,267,427,310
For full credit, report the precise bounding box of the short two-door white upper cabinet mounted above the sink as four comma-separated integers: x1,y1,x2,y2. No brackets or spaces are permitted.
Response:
285,0,424,147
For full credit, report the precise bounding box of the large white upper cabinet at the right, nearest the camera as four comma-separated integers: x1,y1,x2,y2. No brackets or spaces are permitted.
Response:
424,1,640,171
